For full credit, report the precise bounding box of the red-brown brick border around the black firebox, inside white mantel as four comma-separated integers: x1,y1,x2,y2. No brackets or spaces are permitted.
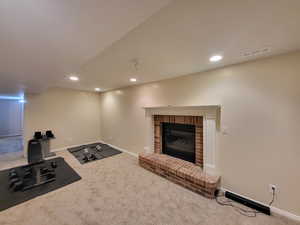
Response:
153,115,203,167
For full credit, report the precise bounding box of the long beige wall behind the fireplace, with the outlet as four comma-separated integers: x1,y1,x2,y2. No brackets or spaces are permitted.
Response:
101,52,300,215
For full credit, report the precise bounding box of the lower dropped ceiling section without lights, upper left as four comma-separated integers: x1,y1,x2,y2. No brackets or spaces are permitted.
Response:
0,0,170,93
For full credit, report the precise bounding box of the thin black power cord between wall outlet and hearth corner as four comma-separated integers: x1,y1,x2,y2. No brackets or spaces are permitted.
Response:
215,188,275,217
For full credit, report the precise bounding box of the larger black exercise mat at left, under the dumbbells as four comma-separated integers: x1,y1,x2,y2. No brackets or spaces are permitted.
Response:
0,157,81,214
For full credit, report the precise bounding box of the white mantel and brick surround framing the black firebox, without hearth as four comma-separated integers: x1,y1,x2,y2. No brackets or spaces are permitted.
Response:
144,105,221,175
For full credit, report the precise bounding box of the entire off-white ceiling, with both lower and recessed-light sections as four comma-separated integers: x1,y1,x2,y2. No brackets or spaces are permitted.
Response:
0,0,300,93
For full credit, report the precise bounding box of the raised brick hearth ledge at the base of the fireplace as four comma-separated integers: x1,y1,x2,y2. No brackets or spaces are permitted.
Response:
139,153,220,198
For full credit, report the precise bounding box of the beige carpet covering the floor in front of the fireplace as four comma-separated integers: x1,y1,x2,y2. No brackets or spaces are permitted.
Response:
0,152,296,225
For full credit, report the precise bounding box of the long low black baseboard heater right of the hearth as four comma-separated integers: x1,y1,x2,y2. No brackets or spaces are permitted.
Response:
225,191,271,215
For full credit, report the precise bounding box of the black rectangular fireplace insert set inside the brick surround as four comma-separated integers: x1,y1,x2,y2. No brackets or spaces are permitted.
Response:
162,123,195,163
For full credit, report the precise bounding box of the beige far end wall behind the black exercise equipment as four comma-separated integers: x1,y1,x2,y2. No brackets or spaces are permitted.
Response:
24,88,100,152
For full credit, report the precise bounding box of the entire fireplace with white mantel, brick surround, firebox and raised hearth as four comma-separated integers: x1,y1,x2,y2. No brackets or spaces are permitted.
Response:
139,105,221,198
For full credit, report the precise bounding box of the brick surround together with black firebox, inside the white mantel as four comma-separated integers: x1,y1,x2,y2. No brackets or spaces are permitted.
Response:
153,115,203,167
